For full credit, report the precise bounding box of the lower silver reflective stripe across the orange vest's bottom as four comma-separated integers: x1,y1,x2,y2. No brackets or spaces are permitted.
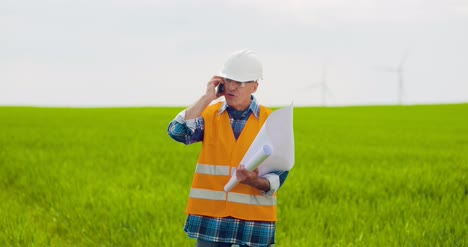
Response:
190,188,276,206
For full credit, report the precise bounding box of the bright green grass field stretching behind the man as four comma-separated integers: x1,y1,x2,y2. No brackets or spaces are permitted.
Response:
0,104,468,247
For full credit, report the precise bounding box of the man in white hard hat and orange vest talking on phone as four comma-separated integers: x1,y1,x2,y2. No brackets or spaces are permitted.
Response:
168,50,288,247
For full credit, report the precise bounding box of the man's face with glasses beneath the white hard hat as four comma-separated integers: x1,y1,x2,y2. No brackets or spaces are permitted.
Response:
224,78,258,111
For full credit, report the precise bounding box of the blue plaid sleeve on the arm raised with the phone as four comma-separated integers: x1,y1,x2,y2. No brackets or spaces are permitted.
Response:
167,110,205,145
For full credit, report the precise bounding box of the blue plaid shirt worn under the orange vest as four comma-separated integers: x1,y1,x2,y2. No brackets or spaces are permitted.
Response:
168,96,288,246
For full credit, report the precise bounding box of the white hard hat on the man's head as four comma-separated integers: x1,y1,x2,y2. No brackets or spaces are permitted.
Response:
219,49,263,82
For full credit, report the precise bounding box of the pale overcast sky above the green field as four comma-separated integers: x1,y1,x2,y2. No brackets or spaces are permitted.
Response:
0,0,468,107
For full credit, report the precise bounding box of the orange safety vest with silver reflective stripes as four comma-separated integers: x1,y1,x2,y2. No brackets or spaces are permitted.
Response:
186,102,277,221
